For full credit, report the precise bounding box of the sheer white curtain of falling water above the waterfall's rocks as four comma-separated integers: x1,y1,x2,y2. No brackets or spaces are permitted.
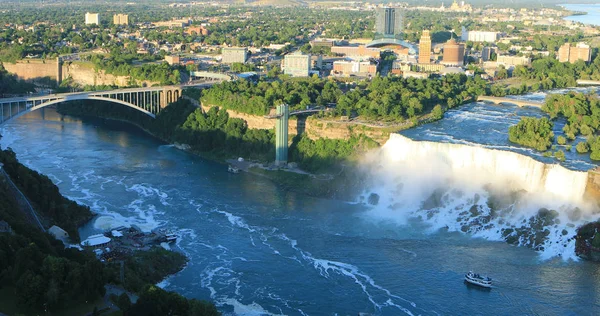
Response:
383,134,588,202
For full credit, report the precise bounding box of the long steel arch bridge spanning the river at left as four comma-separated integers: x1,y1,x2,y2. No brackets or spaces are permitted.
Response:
0,86,181,124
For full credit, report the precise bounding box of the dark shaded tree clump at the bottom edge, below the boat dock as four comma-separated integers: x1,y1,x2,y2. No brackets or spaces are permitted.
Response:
128,285,221,316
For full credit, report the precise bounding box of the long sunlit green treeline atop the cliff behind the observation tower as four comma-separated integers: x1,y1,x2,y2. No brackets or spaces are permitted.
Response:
201,75,487,121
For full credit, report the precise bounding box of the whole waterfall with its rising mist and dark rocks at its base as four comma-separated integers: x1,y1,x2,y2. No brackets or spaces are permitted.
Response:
363,134,597,258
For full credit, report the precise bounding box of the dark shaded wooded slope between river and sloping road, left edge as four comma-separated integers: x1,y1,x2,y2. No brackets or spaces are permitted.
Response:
0,149,92,241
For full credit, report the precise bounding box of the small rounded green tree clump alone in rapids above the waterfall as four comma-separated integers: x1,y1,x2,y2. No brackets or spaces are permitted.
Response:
508,117,554,151
